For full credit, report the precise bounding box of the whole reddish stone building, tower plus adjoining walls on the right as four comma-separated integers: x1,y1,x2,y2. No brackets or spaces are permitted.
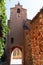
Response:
5,3,43,65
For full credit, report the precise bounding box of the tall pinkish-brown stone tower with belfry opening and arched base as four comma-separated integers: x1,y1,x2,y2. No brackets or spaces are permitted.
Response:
5,3,27,63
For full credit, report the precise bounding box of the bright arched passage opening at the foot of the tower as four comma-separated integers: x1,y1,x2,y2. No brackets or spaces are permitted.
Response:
10,47,23,65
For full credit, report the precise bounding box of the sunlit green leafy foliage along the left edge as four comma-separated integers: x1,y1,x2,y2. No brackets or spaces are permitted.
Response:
0,0,8,57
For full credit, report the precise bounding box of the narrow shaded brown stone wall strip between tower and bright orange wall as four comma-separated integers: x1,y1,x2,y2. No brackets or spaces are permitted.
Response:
24,29,33,65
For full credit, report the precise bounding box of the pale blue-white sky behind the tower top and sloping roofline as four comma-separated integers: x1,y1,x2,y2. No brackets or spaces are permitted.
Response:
6,0,43,19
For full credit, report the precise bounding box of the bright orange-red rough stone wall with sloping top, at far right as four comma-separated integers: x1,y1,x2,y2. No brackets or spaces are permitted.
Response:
31,13,43,65
